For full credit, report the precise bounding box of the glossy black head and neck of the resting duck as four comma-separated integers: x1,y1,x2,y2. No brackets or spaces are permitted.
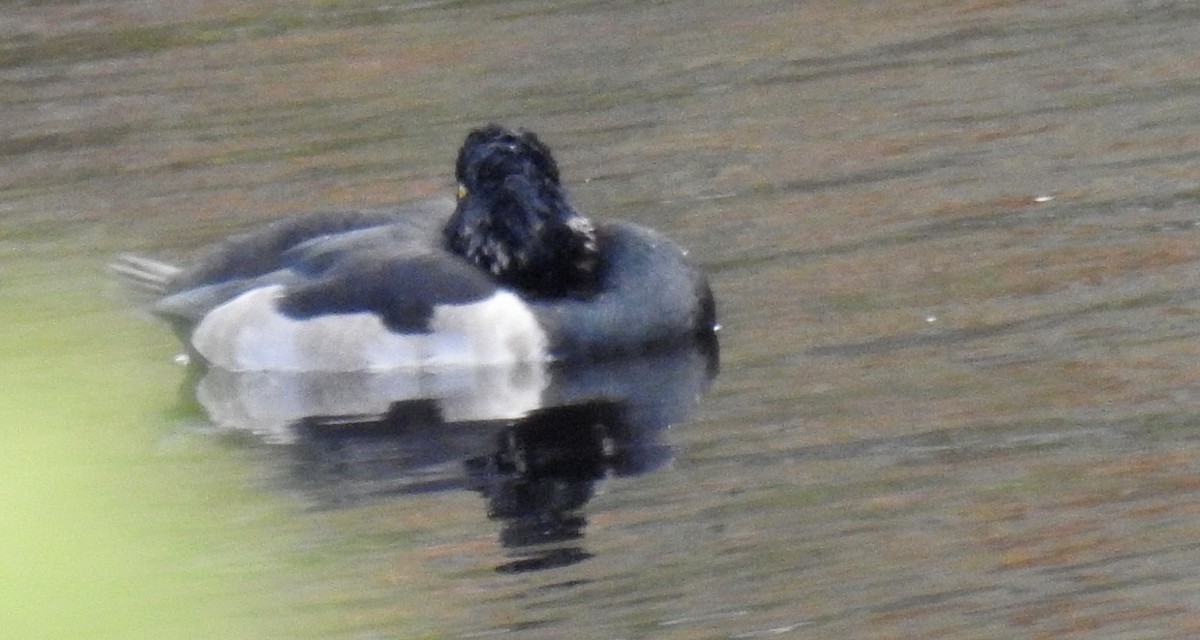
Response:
444,125,599,297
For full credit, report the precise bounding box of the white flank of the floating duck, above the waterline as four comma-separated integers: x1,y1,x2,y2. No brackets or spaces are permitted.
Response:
192,286,546,371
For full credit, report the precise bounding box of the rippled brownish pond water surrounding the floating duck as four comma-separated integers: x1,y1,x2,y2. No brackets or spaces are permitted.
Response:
7,0,1200,639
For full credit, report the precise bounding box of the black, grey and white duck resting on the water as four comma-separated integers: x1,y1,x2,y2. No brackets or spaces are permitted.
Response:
113,124,718,372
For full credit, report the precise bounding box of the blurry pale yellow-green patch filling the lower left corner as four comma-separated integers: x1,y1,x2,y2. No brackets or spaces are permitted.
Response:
0,256,434,639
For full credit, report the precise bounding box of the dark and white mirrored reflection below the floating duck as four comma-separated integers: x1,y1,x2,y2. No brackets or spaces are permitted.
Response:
196,341,718,572
